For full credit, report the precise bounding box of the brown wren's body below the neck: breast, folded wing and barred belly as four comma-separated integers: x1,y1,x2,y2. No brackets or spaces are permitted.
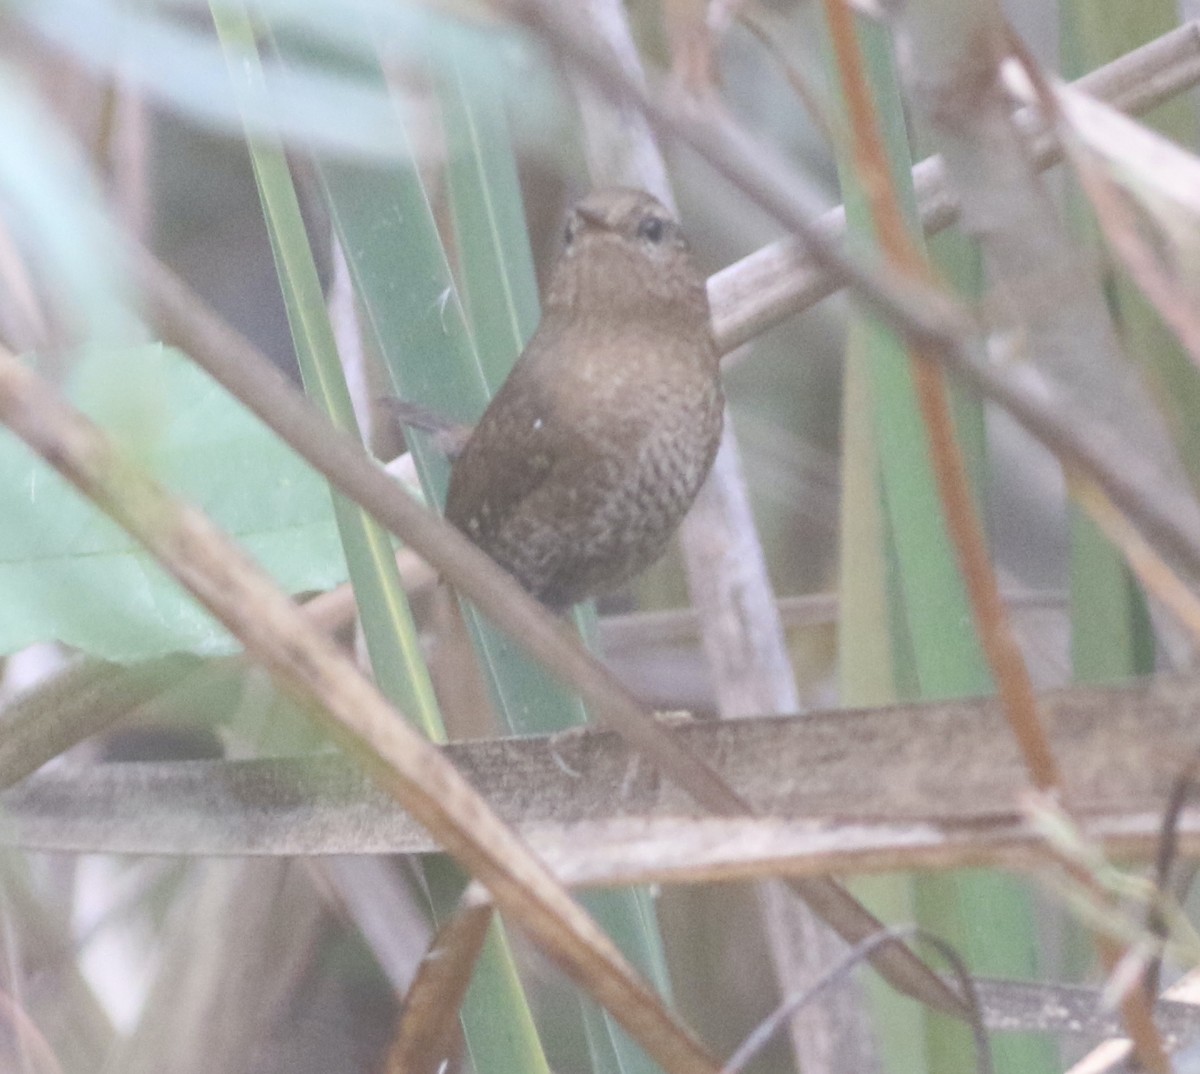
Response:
446,321,725,607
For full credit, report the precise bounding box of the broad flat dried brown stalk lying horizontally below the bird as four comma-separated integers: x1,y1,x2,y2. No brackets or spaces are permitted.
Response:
0,676,1200,884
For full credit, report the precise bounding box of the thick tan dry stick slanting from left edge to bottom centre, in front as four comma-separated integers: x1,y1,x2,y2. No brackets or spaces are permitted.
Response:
0,353,716,1074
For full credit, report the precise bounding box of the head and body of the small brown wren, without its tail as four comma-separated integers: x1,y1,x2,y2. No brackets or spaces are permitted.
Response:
446,188,725,608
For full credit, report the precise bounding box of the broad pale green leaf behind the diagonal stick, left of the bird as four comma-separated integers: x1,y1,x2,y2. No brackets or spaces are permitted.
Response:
0,344,346,661
